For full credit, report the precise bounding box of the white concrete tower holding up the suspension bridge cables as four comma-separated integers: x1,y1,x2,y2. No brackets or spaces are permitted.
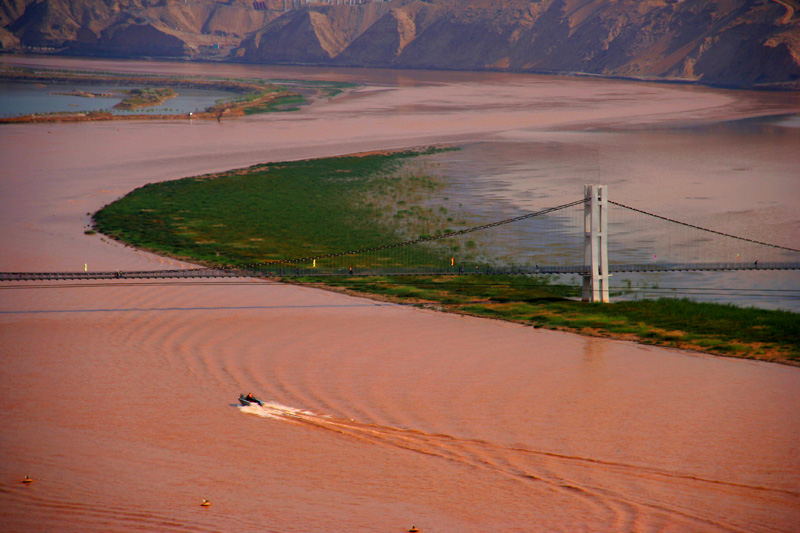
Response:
582,185,608,303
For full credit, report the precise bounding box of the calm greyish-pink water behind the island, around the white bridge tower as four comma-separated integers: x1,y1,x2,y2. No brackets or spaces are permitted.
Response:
418,117,800,311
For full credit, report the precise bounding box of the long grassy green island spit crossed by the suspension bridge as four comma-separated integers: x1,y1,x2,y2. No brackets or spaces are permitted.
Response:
94,148,800,365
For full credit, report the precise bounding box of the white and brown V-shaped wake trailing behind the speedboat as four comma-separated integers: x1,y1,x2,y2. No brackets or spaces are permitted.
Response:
238,401,800,531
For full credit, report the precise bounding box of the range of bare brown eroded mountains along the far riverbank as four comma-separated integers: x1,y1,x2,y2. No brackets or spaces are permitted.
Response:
0,0,800,89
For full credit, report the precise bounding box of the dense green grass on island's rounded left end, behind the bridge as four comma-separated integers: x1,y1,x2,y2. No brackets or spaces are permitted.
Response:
93,149,456,265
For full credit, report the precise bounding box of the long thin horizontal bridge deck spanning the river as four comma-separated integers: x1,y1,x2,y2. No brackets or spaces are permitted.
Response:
0,262,800,281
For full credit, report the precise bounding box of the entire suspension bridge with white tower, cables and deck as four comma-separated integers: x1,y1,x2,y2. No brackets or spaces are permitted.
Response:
0,185,800,302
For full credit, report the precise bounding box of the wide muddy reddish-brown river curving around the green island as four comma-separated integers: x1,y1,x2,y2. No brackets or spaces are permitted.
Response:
0,57,800,533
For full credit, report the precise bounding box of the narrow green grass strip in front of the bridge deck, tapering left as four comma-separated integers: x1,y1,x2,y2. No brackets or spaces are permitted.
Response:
303,275,800,364
